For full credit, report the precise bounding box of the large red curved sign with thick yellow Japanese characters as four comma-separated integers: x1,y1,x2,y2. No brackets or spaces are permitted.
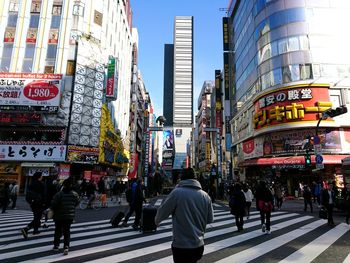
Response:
253,85,332,130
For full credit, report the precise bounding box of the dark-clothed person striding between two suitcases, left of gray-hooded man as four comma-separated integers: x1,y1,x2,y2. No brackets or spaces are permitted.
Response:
122,179,146,230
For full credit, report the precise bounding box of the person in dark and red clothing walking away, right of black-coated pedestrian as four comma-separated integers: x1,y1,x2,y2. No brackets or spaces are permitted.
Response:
255,181,273,234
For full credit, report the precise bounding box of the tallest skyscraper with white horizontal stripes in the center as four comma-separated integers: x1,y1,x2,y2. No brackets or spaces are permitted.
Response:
173,16,193,126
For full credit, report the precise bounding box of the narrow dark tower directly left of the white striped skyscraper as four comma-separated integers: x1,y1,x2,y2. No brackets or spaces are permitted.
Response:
163,44,174,126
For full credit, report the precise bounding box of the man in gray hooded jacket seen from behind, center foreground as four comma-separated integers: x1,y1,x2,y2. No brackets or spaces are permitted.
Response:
155,168,214,263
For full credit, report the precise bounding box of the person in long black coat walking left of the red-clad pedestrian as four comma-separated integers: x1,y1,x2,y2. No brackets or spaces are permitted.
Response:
229,183,246,232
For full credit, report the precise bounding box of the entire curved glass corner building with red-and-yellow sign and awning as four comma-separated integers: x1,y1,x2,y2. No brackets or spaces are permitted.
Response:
224,0,350,192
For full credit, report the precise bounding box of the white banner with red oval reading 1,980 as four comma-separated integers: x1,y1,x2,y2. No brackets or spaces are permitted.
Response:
0,73,62,106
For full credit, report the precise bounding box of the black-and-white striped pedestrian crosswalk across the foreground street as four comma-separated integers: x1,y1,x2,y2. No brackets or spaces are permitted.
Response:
0,208,350,263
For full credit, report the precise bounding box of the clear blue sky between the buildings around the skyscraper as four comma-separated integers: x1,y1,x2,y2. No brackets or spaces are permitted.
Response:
131,0,229,116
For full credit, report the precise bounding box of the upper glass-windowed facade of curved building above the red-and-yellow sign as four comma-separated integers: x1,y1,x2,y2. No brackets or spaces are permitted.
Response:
230,0,350,108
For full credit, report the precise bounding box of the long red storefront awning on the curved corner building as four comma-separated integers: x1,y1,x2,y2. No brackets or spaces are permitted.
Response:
239,155,350,166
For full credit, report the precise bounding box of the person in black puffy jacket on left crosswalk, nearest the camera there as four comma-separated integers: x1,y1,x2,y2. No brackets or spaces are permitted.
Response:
51,178,79,255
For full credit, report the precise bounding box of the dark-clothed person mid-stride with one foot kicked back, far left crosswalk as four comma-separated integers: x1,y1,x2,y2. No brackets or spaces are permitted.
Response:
21,172,45,239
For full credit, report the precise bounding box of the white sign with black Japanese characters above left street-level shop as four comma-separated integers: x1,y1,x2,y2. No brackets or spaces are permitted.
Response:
0,144,67,162
